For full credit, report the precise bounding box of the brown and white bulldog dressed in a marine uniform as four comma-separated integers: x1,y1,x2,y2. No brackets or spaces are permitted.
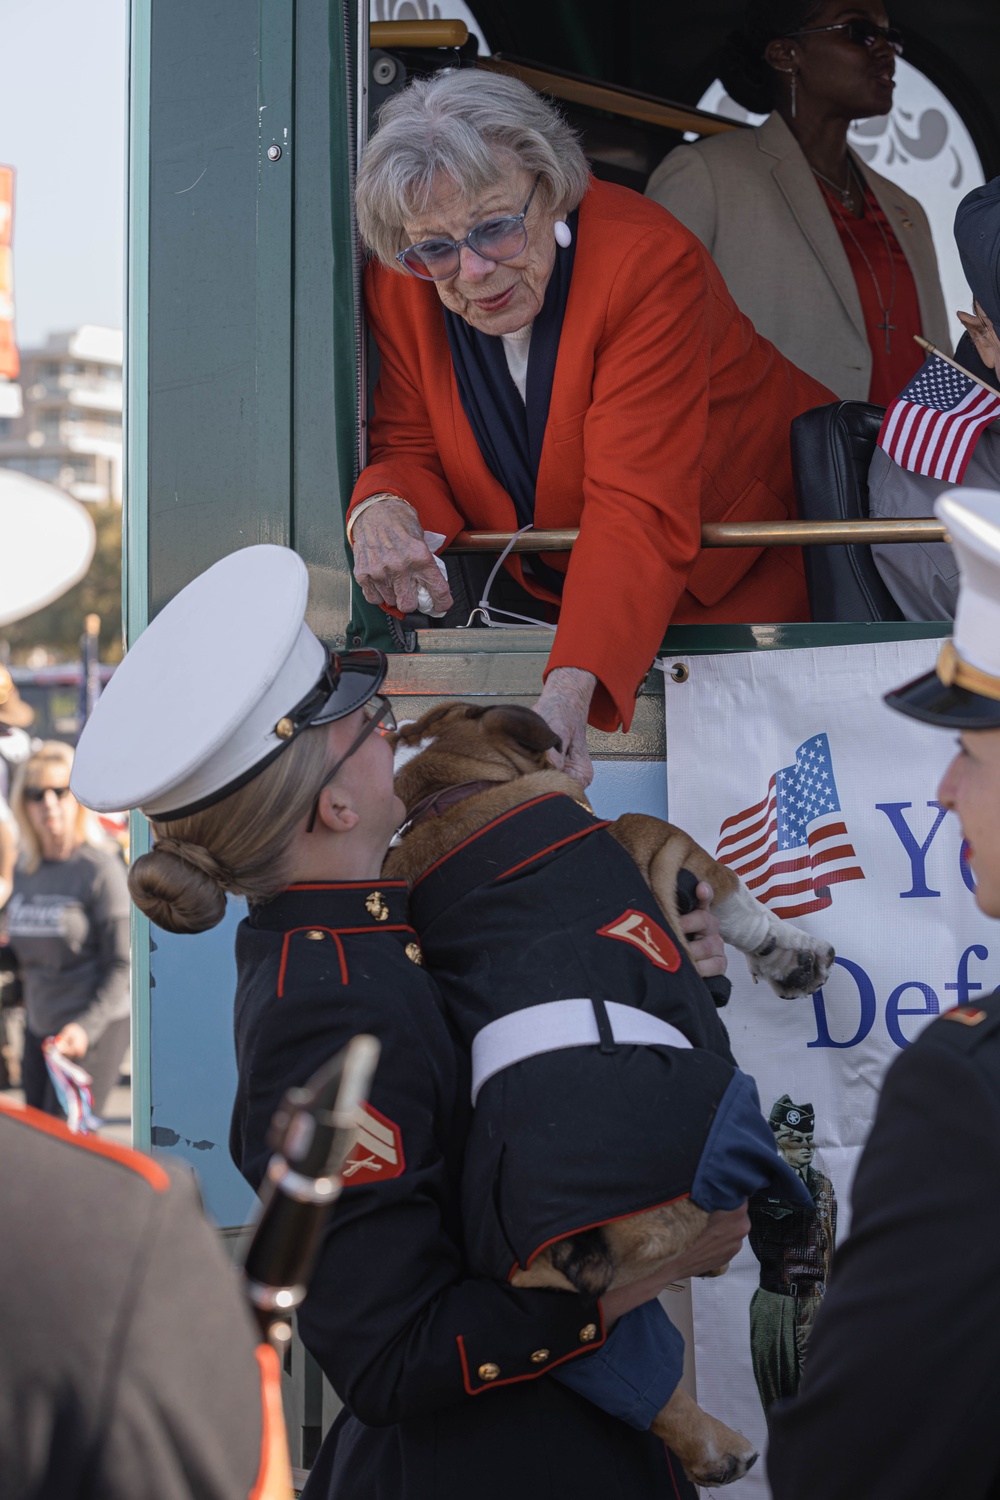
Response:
384,704,834,1485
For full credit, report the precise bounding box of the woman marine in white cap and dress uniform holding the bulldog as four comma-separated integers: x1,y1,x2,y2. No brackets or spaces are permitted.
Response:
73,546,758,1500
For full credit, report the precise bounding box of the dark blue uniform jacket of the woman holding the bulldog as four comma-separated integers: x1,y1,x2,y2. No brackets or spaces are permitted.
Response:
231,882,690,1500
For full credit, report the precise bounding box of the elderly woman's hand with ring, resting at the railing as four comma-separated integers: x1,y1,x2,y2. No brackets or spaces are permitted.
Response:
351,498,451,615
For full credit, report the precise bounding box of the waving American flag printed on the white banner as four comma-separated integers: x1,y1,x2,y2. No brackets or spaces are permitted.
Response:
715,735,865,917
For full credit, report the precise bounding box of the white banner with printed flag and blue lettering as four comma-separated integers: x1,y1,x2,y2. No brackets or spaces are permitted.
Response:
664,641,1000,1500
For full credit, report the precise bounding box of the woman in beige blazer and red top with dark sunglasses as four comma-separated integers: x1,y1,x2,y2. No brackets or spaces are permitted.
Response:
646,0,951,407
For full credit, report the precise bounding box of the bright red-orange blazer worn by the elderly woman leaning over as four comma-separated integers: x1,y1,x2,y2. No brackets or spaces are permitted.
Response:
351,182,835,729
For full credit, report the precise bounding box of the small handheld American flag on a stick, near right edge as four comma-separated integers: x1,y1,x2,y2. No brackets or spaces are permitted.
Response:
879,354,1000,485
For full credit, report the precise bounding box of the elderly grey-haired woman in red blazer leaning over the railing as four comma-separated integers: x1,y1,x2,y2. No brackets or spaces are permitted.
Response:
348,71,834,783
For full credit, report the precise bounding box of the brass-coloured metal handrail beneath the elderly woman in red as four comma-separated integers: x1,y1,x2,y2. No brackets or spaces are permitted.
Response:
445,516,949,552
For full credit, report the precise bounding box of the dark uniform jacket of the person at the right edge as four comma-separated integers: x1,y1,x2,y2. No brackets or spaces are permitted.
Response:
768,992,1000,1500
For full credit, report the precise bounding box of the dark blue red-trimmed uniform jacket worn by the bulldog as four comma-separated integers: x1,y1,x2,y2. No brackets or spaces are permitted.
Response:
411,794,773,1277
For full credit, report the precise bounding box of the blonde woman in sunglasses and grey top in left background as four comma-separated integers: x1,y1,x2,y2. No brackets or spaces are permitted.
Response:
4,740,129,1118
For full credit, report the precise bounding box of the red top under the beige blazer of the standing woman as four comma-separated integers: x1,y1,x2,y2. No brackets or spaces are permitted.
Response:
817,179,924,407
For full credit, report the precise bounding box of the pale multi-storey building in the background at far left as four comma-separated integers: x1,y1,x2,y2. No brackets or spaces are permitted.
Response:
0,324,121,504
